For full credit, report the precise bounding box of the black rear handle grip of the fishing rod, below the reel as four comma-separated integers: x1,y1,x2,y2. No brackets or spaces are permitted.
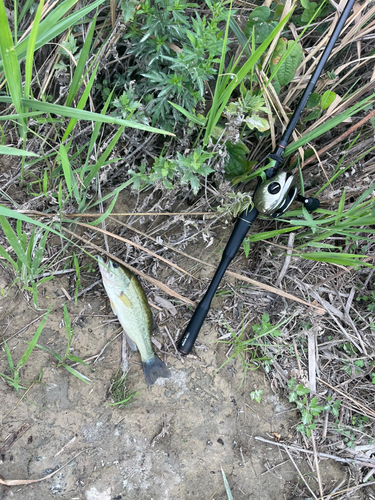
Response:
177,207,259,356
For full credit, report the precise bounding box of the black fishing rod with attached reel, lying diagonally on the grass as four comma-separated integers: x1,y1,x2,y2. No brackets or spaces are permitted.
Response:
177,0,356,355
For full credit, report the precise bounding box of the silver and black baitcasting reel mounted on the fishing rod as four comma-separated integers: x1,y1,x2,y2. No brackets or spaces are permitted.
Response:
254,172,320,219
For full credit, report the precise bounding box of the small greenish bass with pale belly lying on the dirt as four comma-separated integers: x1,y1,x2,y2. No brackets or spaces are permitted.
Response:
98,257,171,386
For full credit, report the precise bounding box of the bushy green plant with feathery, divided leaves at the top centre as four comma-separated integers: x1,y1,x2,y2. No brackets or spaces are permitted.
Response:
121,0,229,130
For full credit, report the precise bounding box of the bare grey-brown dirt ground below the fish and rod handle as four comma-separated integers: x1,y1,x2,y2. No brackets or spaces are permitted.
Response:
0,258,352,500
